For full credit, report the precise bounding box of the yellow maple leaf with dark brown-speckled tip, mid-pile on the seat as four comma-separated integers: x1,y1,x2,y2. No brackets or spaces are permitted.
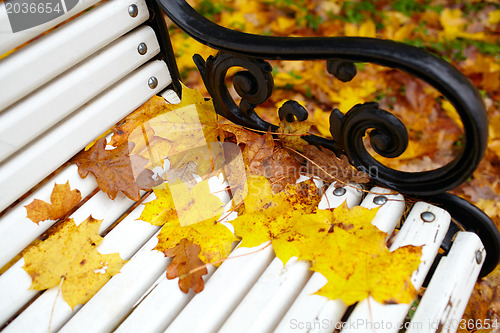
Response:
231,176,320,247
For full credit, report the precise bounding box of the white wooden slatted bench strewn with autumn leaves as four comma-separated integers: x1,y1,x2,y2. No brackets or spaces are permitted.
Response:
0,0,496,332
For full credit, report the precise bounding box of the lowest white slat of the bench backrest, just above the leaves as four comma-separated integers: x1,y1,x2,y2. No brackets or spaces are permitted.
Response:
0,60,172,211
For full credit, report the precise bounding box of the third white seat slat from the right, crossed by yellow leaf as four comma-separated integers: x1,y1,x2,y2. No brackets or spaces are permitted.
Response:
276,187,405,332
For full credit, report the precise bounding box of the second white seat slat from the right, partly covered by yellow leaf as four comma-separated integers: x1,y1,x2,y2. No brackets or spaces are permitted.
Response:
342,202,451,333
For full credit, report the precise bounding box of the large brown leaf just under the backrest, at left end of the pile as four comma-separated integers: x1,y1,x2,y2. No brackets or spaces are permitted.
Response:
74,138,154,201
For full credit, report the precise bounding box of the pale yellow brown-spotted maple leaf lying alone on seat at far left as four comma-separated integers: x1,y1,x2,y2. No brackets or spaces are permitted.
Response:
23,216,125,309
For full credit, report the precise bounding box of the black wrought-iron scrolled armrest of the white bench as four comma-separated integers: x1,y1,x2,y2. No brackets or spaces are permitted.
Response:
157,0,500,274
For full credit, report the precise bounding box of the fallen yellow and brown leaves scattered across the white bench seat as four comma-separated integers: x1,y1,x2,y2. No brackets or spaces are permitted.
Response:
18,87,420,307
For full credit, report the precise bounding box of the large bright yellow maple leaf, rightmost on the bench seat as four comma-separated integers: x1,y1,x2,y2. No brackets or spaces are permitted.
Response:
273,203,422,305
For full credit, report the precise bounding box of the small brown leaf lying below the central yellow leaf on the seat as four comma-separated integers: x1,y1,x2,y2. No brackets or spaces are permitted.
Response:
163,238,208,293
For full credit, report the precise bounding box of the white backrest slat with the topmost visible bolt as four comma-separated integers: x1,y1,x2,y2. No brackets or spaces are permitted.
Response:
0,0,149,110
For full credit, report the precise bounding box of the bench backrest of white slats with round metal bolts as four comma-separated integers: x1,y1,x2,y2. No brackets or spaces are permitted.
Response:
0,0,175,211
